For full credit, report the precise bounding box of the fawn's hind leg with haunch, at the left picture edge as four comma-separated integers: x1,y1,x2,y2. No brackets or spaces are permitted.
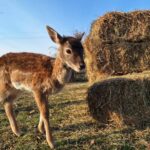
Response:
0,67,20,136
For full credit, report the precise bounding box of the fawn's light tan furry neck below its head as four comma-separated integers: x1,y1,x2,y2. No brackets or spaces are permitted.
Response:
52,57,72,85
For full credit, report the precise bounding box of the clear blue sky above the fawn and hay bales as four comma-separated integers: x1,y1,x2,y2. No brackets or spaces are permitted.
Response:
0,0,150,55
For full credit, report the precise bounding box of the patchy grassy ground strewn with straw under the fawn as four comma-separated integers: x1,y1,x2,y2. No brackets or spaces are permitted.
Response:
0,83,150,150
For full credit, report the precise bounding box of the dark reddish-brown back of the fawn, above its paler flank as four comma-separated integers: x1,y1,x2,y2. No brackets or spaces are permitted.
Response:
0,53,53,74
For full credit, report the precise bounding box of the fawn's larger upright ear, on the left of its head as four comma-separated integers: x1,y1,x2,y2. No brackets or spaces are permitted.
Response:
46,26,63,44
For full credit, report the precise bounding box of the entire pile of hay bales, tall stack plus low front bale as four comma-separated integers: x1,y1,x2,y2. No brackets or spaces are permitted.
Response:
84,11,150,124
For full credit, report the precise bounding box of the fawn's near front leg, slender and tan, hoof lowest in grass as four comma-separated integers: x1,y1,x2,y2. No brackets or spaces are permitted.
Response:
34,92,54,149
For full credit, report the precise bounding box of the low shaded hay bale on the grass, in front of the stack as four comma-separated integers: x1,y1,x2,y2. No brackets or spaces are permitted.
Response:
87,72,150,126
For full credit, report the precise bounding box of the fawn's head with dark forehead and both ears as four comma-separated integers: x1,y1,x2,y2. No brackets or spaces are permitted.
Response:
47,26,85,72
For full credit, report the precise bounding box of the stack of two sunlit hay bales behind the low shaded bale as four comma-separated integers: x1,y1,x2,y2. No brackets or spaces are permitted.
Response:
84,11,150,81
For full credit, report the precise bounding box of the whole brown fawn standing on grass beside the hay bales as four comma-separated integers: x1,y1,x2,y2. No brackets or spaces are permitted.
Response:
0,26,85,149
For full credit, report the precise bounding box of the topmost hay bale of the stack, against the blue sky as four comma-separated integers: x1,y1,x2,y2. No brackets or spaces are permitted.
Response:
91,11,150,43
